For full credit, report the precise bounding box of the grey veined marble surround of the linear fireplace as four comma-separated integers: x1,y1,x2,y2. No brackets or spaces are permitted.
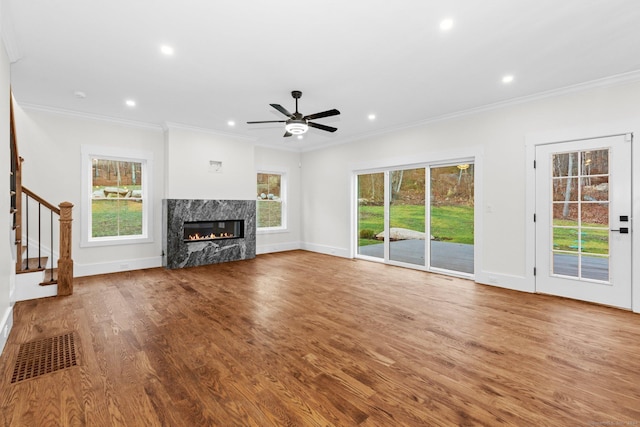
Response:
162,199,256,269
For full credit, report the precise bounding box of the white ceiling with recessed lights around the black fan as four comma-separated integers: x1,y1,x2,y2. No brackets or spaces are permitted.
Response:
1,0,640,151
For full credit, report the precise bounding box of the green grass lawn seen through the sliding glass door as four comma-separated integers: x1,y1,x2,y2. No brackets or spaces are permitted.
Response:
358,205,473,246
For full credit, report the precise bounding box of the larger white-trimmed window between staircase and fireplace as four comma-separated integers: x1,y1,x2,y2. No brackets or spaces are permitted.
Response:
81,147,152,246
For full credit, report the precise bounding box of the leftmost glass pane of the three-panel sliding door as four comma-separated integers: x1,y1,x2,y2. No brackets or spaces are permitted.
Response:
358,172,384,258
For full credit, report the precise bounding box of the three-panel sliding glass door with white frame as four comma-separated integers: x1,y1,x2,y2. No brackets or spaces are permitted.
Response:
356,160,474,276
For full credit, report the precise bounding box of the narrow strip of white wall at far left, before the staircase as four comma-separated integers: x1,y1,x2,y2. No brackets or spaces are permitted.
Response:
0,31,15,353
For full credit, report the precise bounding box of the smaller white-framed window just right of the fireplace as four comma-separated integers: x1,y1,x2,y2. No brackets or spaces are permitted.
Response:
256,172,286,230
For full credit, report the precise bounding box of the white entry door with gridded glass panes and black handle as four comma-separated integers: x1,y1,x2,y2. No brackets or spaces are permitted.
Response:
536,135,631,308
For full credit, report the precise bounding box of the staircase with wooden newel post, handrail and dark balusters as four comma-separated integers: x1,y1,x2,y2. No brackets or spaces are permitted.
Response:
10,93,73,301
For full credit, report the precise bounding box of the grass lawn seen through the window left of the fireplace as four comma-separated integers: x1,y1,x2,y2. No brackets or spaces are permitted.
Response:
91,199,142,237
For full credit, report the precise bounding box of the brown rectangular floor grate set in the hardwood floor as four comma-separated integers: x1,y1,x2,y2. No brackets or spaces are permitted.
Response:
11,332,78,384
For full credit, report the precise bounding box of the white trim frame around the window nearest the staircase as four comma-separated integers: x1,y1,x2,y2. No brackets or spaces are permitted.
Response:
80,145,153,247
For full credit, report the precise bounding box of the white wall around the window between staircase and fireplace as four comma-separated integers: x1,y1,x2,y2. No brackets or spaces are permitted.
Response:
15,108,164,276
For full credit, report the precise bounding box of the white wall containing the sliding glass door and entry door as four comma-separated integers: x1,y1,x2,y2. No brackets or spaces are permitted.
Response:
302,82,640,294
